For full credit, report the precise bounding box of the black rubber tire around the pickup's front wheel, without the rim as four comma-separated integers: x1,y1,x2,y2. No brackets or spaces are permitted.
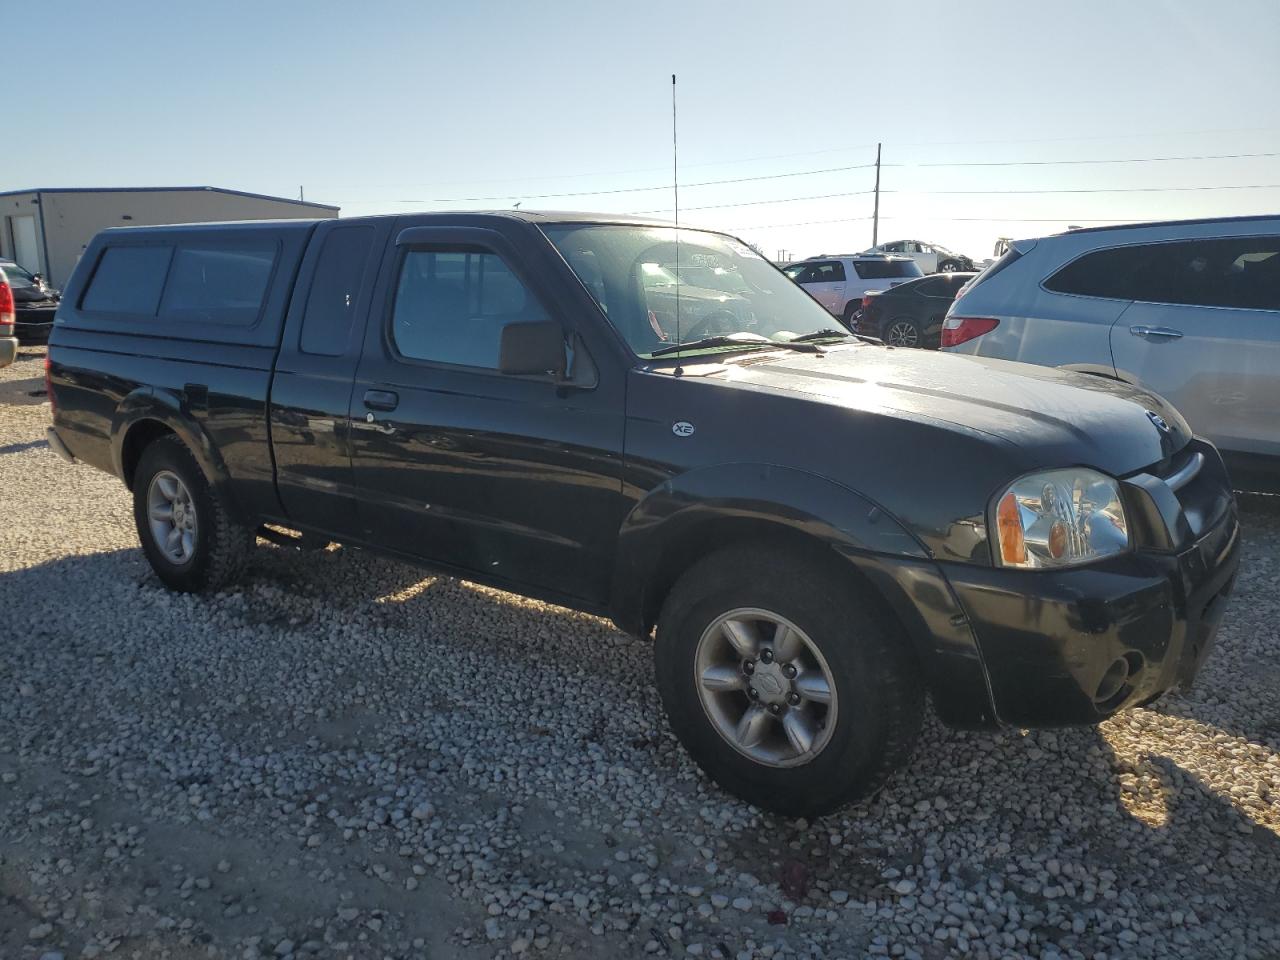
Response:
654,544,924,817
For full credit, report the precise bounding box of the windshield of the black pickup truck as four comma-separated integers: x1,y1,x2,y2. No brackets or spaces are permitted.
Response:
544,224,840,357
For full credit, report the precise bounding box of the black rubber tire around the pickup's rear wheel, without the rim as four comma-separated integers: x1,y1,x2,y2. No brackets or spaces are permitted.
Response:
133,436,253,593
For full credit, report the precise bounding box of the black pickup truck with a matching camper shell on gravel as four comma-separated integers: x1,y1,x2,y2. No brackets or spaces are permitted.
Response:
47,211,1239,814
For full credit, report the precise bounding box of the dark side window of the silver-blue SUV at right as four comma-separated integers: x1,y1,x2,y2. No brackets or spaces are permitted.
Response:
1044,237,1280,310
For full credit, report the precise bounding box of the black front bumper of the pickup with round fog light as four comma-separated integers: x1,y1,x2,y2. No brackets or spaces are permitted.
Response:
945,504,1240,727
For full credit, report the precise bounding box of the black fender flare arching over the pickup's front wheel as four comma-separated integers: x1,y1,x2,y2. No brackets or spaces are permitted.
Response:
611,462,931,634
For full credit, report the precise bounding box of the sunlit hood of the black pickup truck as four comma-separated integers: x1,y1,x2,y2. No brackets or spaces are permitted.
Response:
722,344,1192,476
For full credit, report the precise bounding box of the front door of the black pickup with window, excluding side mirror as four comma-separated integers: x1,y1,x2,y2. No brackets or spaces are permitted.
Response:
352,227,625,605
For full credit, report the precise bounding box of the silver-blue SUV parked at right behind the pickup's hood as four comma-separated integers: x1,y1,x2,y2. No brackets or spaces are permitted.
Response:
942,216,1280,490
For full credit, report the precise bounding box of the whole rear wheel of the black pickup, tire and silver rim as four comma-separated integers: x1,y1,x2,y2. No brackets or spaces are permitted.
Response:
133,436,253,593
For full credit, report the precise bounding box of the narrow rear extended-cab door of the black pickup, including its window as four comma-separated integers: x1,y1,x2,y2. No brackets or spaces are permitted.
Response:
270,220,390,536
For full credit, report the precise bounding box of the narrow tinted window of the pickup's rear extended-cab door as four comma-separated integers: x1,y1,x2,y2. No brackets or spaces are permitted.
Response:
298,227,374,357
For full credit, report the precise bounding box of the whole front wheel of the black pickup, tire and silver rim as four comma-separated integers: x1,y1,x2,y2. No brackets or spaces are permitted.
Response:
654,547,923,817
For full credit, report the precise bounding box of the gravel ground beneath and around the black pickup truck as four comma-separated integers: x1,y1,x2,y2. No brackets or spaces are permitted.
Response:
0,352,1280,960
